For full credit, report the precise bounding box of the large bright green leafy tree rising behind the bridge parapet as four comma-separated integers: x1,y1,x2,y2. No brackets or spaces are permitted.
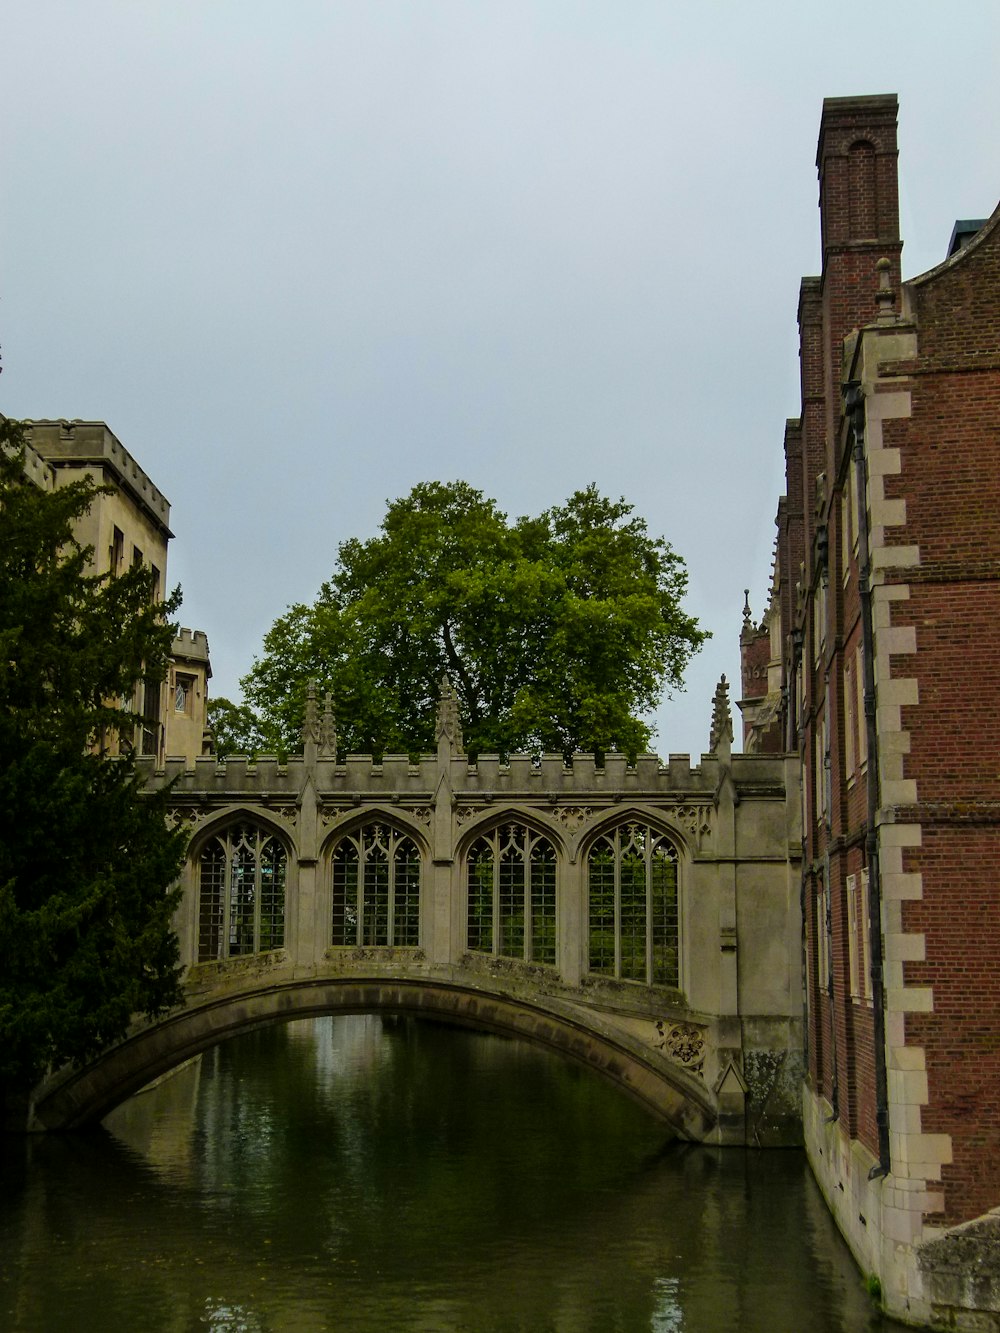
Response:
241,481,707,754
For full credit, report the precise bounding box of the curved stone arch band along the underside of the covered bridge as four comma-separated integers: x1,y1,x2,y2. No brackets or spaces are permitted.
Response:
31,976,717,1142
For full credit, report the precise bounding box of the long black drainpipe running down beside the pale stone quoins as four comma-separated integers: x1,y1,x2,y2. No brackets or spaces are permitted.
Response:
845,381,891,1180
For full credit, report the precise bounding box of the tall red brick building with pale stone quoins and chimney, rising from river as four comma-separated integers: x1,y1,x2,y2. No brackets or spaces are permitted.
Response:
741,96,1000,1328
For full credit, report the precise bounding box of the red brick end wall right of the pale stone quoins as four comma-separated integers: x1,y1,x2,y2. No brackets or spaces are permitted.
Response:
885,213,1000,1224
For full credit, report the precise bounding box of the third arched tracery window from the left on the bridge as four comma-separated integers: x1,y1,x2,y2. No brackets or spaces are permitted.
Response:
468,824,556,965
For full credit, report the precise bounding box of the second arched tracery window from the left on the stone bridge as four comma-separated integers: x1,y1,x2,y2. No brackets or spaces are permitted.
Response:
332,824,420,945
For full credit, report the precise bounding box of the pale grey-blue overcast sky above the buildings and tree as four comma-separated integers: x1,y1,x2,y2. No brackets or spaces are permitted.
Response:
0,0,1000,756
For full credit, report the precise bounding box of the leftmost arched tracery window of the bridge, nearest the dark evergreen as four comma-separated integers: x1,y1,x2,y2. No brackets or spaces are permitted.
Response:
197,824,287,962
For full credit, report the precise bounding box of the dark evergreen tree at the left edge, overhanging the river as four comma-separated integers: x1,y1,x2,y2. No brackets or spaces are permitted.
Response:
0,419,184,1101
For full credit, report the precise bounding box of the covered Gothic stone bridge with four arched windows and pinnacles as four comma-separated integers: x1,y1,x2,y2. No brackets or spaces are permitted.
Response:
27,684,801,1142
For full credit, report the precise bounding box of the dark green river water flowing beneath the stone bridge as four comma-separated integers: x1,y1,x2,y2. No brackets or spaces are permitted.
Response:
0,1016,899,1333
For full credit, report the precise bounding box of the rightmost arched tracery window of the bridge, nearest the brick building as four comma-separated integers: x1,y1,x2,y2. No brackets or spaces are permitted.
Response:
587,822,680,986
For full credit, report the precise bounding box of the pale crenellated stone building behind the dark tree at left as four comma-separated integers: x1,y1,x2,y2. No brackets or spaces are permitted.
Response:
18,421,212,762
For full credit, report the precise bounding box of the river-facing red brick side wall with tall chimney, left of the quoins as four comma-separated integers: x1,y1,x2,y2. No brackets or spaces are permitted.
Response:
783,97,901,1152
